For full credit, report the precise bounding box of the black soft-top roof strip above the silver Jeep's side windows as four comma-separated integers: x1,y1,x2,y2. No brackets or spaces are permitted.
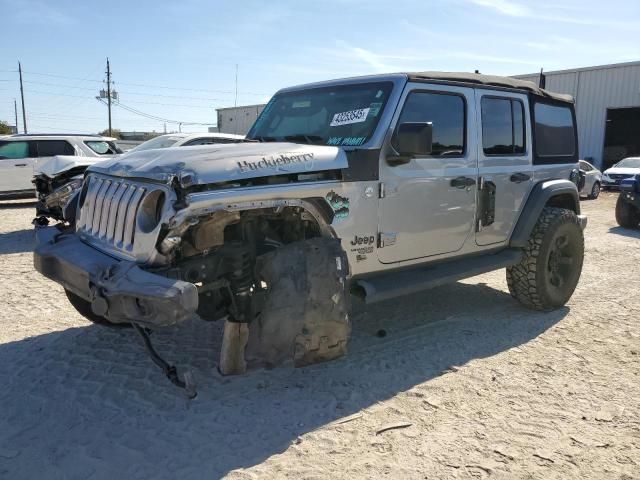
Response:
407,72,574,103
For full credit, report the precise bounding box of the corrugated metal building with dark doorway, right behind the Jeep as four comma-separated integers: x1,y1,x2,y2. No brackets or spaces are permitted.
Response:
516,62,640,169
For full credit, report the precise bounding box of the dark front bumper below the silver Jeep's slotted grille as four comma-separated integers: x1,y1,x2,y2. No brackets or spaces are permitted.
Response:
34,227,198,327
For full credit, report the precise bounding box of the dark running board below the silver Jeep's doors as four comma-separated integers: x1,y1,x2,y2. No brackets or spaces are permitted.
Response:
352,248,523,304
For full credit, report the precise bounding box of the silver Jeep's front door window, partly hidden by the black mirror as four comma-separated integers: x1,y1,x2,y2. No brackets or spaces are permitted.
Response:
399,92,466,157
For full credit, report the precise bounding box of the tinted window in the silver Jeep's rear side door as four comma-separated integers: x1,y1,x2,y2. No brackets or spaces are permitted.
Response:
481,97,525,155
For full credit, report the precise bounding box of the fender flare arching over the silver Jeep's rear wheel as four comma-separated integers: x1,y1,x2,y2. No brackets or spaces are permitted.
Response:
509,180,580,248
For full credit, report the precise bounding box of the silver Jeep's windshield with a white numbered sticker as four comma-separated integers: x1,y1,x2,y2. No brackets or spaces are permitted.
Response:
247,82,393,146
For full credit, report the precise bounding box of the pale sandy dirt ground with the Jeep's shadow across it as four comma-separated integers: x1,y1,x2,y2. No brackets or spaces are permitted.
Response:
0,194,640,480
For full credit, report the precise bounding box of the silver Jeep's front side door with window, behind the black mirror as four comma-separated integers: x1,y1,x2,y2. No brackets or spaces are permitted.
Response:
378,84,477,263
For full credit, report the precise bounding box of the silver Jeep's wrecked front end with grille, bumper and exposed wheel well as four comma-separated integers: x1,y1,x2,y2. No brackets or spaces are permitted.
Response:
34,141,349,384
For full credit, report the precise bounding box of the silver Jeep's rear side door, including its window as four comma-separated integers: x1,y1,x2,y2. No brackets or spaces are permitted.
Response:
476,89,533,245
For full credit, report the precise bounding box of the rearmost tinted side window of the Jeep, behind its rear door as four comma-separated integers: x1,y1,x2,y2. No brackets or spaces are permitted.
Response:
534,102,576,157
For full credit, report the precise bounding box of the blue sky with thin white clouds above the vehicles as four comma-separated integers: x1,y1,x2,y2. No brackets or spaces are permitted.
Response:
0,0,640,132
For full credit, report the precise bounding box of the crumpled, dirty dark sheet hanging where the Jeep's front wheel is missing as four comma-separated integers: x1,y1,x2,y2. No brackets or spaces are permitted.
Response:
245,238,351,367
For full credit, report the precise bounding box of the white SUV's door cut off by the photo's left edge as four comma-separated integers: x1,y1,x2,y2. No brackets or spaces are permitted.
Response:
0,140,36,192
